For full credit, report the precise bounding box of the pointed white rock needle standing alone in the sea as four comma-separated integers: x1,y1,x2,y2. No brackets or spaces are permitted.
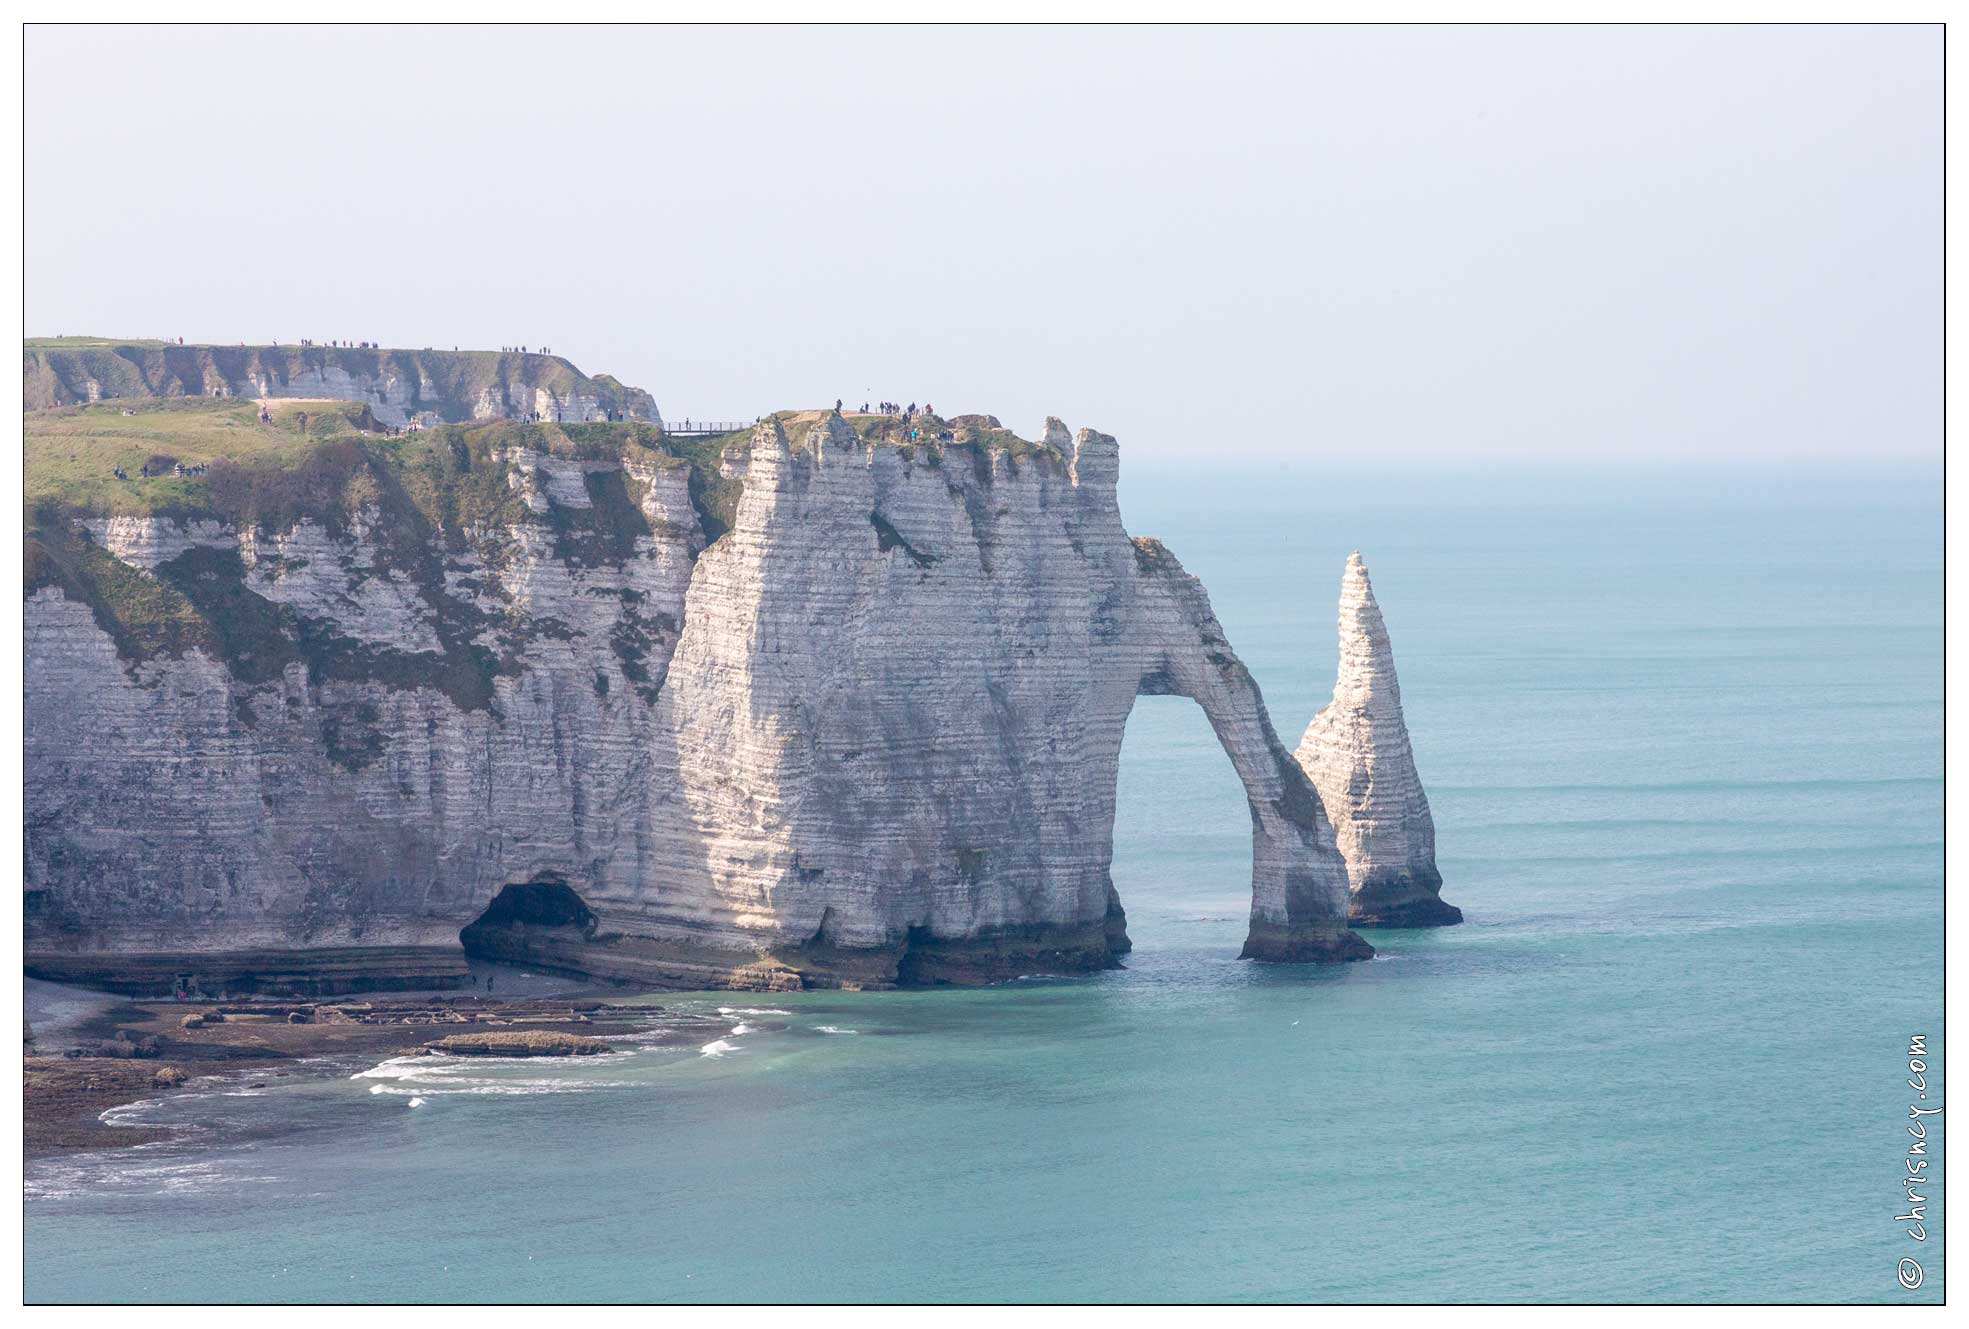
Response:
1298,553,1463,927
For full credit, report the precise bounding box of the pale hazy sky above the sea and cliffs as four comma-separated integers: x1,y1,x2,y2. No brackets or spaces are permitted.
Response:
26,26,1941,459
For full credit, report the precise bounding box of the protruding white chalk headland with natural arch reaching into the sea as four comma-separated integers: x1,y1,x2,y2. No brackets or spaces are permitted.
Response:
658,415,1372,982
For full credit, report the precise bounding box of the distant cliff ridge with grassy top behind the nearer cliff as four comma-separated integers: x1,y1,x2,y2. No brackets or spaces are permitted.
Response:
24,339,662,425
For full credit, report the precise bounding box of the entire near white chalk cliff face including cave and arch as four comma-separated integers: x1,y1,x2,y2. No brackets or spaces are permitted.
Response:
26,415,1370,986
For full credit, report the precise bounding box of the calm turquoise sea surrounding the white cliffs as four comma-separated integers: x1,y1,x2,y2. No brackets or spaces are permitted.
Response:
26,467,1943,1301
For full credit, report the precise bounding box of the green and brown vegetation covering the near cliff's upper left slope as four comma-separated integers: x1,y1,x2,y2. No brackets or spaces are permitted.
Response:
26,398,716,716
